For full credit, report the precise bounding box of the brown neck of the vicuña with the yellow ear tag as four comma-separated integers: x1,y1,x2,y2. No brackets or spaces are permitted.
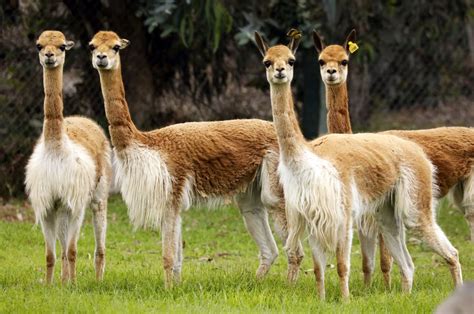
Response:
326,83,352,133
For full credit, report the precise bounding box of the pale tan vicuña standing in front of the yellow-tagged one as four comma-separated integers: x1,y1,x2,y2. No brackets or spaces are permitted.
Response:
255,33,462,299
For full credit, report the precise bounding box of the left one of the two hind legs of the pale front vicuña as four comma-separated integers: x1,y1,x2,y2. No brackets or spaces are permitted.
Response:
377,206,415,293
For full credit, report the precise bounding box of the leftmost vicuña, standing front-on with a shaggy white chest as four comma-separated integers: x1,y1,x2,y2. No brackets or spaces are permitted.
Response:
26,31,112,283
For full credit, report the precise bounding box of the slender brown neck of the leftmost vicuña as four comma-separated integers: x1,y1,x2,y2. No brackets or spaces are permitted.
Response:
43,66,64,142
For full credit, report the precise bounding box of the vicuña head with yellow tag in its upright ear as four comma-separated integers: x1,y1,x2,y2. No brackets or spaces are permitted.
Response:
313,29,356,85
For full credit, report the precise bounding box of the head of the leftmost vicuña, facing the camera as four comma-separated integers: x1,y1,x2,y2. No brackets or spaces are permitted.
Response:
36,31,74,69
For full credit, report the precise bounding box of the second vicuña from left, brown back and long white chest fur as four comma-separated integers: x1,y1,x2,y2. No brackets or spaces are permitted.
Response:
89,31,302,287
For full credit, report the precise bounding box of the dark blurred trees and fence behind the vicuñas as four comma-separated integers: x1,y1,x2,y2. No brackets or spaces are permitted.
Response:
0,0,474,199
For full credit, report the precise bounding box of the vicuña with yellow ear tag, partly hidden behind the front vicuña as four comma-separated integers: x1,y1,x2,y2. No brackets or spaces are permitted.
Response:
313,30,474,287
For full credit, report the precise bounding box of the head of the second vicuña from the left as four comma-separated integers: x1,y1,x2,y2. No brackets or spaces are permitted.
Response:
89,31,130,70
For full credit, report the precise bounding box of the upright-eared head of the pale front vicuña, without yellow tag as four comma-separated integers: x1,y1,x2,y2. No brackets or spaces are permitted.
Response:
255,32,300,85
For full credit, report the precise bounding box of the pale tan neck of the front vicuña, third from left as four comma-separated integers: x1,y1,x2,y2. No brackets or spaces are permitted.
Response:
270,84,306,160
